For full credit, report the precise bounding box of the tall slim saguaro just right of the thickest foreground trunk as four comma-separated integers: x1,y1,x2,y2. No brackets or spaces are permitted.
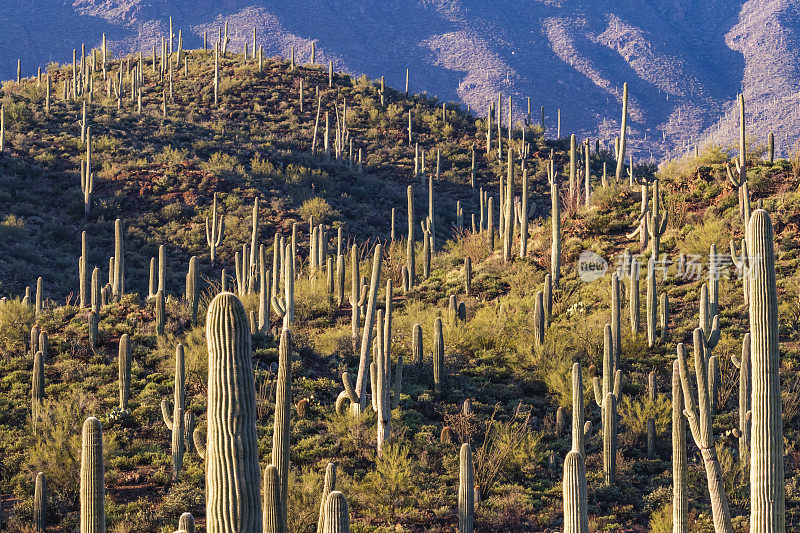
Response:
272,329,294,524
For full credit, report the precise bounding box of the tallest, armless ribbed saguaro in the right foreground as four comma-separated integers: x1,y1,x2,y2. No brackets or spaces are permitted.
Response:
747,209,786,533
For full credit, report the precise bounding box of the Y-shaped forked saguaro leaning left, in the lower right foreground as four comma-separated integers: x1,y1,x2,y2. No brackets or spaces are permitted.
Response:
677,328,733,533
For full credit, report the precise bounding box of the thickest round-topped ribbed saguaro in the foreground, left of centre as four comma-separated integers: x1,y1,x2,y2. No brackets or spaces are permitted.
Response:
205,293,262,533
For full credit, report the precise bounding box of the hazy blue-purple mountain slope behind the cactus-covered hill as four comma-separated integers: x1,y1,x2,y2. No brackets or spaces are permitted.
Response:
0,0,800,159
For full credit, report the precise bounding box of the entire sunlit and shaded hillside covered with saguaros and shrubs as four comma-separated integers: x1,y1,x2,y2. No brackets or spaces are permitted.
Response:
0,18,800,533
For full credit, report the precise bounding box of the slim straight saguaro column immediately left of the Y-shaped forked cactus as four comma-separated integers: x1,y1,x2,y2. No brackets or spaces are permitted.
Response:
672,360,689,533
